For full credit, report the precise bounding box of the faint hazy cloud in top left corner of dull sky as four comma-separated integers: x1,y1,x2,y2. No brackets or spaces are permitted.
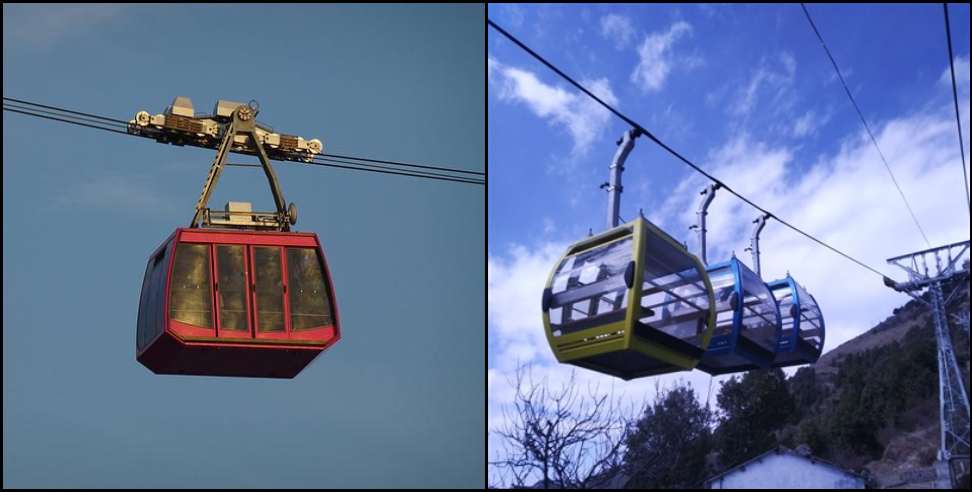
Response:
3,5,122,48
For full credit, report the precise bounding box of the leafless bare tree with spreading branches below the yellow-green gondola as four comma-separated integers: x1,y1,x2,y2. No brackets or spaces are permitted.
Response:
489,365,629,489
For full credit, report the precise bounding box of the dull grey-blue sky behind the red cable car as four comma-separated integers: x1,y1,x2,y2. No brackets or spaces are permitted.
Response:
3,5,485,488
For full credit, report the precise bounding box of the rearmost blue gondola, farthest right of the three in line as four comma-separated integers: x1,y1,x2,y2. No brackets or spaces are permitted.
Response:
767,274,824,367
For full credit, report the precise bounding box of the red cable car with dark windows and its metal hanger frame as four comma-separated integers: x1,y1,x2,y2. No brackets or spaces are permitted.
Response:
136,99,341,378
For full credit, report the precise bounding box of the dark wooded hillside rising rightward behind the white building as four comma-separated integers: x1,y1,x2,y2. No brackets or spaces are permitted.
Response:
623,272,969,488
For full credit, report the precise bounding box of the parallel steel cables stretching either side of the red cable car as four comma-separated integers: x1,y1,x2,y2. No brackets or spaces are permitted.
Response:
3,103,486,185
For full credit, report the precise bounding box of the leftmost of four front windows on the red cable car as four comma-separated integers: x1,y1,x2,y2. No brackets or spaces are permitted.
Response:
169,243,213,328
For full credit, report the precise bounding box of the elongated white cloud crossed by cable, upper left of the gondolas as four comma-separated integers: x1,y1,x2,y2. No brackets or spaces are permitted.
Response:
487,56,618,156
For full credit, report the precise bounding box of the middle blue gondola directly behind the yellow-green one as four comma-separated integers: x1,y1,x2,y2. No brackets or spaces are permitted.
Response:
698,257,781,375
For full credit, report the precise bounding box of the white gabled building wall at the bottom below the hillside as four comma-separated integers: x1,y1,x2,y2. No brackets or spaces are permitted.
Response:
705,446,865,489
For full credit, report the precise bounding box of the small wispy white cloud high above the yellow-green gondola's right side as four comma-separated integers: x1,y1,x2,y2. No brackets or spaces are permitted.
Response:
631,21,703,92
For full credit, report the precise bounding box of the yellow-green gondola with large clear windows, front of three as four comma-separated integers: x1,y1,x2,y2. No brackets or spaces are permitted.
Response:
542,217,716,380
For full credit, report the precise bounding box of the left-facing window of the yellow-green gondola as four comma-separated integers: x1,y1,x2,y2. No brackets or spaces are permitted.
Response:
550,236,633,336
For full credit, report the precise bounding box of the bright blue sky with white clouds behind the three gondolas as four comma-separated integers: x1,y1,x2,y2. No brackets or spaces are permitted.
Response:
487,4,969,486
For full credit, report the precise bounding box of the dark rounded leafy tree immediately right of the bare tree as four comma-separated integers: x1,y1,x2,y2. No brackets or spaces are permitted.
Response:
625,385,712,489
